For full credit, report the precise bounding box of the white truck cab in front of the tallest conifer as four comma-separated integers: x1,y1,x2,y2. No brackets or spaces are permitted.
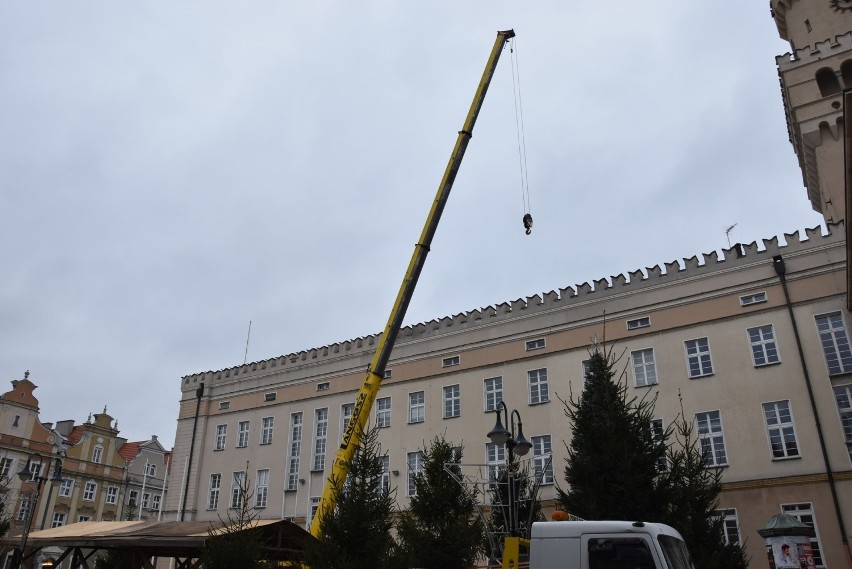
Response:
516,521,694,569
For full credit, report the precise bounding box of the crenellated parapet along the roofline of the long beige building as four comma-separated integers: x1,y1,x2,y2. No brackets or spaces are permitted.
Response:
182,223,845,390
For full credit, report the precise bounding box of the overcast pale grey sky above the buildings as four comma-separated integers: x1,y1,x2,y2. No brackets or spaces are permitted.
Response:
0,0,821,447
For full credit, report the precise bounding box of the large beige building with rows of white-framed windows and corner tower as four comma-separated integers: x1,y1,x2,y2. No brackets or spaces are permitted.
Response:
166,0,852,567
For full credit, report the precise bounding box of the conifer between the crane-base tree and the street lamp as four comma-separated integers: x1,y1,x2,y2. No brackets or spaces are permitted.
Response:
398,436,484,569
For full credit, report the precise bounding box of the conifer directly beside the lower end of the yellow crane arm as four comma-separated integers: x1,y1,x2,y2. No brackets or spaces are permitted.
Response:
305,429,406,569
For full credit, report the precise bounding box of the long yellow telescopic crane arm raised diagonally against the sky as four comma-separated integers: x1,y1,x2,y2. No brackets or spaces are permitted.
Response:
311,30,515,537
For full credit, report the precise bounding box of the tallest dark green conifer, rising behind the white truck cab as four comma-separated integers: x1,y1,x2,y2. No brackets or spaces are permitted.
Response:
558,346,666,521
